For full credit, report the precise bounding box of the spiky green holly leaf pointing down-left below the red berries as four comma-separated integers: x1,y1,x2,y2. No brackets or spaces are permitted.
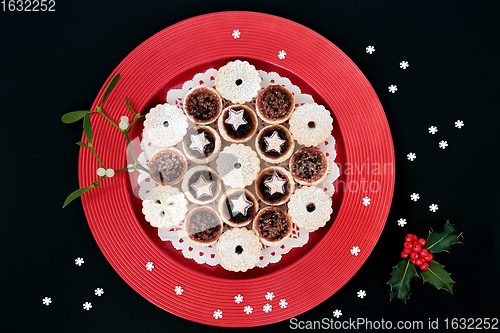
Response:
387,260,418,303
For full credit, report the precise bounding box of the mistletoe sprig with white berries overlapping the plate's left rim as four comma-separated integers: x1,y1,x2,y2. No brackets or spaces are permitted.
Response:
61,74,148,208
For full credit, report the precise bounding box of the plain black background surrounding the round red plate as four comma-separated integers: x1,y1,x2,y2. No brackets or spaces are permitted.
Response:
0,0,500,332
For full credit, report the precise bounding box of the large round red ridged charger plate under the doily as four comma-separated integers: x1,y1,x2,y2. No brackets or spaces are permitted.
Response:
79,12,395,327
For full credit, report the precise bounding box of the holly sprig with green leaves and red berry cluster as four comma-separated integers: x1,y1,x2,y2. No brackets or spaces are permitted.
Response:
387,221,462,303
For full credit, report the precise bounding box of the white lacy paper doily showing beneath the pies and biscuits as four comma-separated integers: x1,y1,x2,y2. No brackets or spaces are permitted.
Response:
128,68,340,267
